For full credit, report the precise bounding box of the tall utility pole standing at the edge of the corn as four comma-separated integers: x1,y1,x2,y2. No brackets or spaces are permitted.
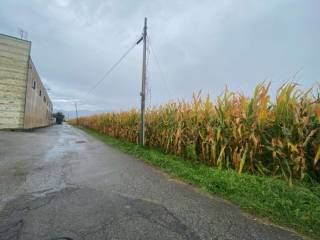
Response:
139,18,147,146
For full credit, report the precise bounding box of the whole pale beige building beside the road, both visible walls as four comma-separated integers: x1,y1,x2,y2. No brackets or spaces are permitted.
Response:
0,34,52,129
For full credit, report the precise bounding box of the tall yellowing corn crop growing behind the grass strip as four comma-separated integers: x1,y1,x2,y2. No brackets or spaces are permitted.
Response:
71,83,320,184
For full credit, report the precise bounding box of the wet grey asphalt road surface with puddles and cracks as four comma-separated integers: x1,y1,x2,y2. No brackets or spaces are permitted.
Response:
0,125,301,240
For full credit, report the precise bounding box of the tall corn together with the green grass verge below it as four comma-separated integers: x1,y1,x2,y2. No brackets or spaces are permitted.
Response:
71,83,320,238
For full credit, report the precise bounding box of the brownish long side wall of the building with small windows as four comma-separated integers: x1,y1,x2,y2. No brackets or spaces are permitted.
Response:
24,58,52,129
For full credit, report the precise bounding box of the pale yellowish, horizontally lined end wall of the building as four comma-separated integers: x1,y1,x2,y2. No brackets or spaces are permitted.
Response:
0,34,31,129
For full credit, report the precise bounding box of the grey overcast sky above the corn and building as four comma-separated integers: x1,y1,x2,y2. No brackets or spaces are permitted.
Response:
0,0,320,111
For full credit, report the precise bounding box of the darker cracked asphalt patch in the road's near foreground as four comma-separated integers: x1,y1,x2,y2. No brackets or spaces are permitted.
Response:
0,187,200,240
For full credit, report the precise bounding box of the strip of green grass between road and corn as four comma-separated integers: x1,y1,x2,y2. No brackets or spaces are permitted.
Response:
81,128,320,239
